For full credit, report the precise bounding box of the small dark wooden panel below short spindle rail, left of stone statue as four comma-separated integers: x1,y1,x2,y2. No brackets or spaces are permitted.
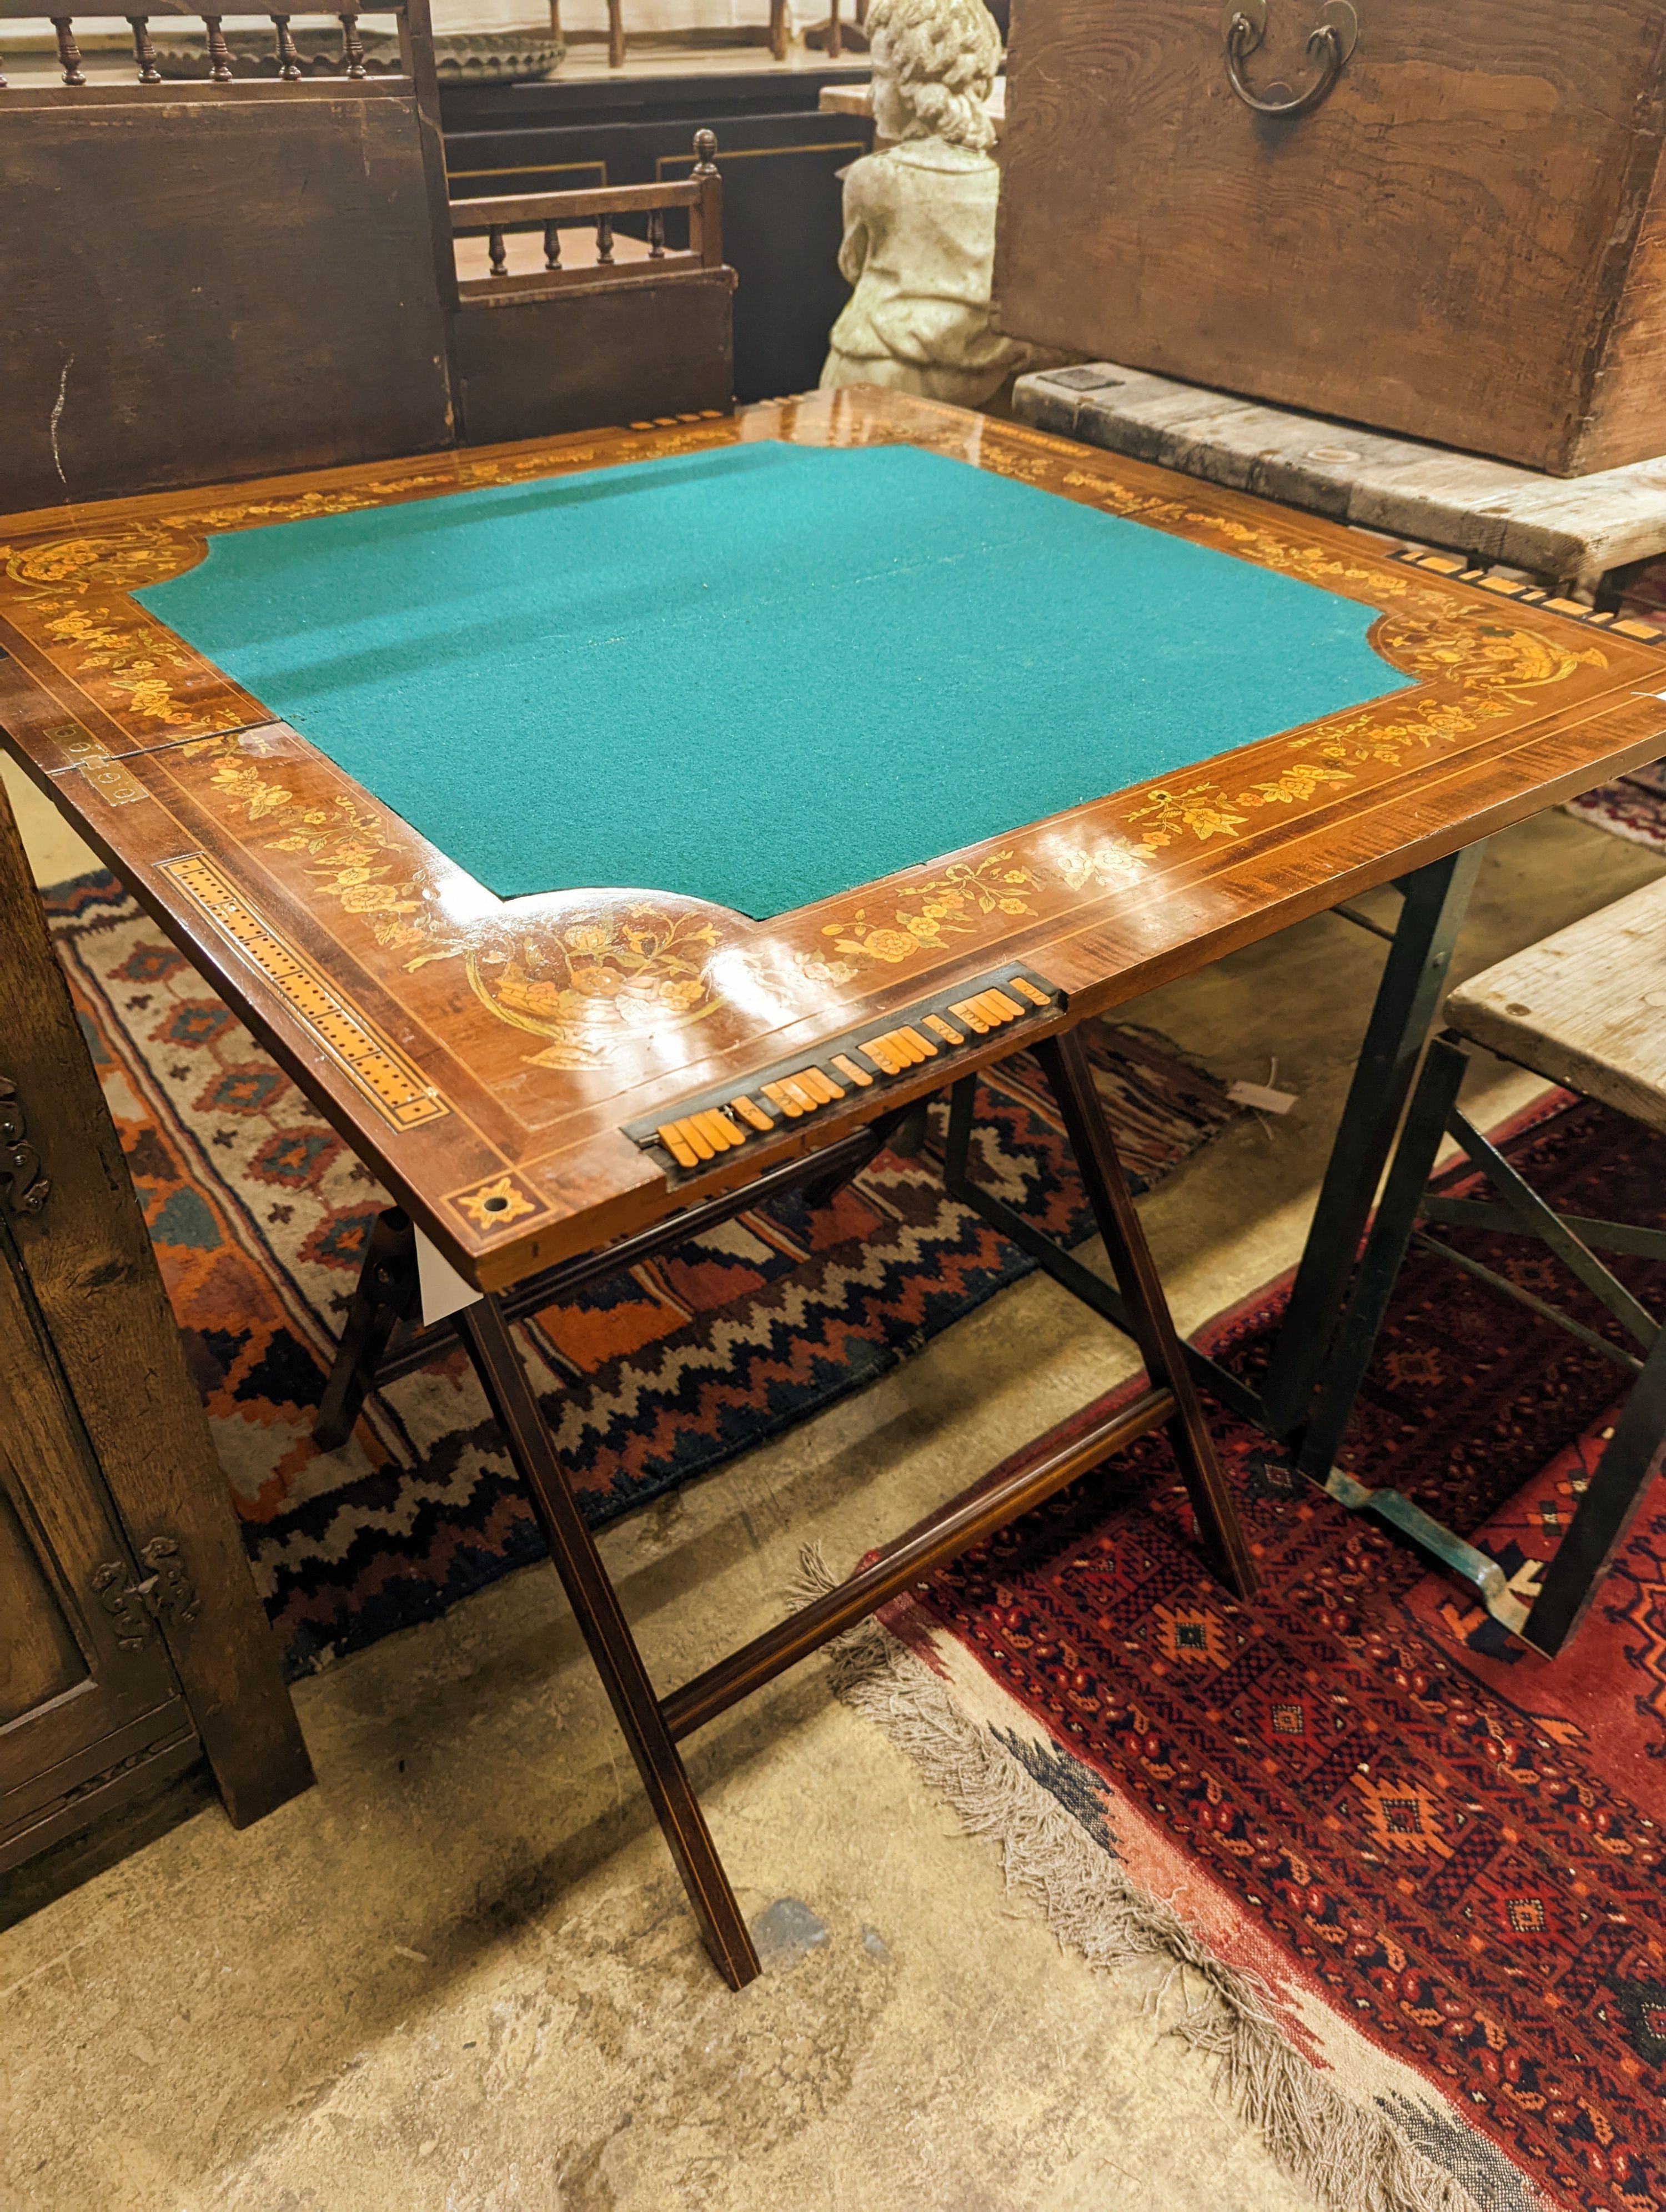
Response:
456,270,735,445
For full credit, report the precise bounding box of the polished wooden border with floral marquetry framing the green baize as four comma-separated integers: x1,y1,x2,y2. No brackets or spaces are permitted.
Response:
0,389,1666,1288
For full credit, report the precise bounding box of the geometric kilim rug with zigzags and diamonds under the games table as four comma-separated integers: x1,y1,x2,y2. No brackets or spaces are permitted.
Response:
47,874,1241,1677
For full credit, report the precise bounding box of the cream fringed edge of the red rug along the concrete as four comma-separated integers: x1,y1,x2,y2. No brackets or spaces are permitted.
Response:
792,1544,1480,2212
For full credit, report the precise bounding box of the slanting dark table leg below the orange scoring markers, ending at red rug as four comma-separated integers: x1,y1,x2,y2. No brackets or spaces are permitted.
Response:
1036,1031,1257,1597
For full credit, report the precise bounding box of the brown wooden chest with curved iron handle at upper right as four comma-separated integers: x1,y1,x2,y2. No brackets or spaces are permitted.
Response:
996,0,1666,476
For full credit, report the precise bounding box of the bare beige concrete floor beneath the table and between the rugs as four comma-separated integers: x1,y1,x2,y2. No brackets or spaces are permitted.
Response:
0,770,1662,2212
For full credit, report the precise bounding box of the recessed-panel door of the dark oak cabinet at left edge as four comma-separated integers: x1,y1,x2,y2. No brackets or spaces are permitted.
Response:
0,1225,199,1867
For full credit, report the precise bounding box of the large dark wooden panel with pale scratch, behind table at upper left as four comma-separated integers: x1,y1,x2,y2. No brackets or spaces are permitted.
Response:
0,86,451,506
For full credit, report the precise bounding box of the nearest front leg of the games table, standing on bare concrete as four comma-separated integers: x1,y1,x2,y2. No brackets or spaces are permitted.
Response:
458,1296,759,1989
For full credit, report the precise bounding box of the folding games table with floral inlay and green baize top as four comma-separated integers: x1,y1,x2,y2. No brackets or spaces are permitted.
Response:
0,389,1666,1987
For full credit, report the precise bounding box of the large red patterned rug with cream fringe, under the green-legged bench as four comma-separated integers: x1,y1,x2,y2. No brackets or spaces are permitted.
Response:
836,1104,1666,2212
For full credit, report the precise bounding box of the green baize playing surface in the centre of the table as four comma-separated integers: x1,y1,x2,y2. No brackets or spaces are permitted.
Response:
137,440,1407,918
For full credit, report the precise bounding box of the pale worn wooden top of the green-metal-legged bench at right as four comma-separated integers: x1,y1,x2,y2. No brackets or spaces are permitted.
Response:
1445,878,1666,1130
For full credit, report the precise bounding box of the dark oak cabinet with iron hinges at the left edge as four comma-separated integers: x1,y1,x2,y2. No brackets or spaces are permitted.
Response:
0,774,312,1916
